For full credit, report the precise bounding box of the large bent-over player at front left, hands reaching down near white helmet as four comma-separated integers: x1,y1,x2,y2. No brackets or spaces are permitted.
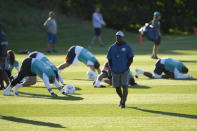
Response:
4,58,64,97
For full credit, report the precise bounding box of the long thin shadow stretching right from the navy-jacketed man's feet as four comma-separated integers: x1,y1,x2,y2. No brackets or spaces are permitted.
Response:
128,107,197,119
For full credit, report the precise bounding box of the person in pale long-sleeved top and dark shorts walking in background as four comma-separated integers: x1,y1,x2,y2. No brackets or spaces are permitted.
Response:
89,8,106,48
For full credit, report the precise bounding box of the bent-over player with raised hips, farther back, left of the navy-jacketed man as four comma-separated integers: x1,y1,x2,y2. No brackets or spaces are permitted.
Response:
58,46,101,74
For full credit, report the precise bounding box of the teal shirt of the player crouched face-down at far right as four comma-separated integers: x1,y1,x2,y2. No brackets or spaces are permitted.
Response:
164,58,184,72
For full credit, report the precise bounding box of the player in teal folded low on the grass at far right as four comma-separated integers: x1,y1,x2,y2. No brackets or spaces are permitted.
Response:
135,58,193,79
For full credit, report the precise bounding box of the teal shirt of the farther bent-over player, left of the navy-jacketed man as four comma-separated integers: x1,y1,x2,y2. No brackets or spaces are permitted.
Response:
78,48,97,66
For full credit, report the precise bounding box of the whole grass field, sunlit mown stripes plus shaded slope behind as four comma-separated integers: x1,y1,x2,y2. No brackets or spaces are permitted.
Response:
0,0,197,131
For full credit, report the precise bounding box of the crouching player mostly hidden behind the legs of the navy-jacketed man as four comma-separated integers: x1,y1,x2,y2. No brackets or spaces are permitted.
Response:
93,62,137,88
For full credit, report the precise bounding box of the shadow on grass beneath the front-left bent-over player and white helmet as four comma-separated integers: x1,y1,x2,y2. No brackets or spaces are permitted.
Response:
18,92,83,101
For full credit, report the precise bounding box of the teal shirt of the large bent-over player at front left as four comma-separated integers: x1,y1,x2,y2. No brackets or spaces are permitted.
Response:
31,59,56,78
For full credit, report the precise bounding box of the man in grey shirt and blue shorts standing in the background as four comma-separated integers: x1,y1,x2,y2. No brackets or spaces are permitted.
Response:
44,11,57,53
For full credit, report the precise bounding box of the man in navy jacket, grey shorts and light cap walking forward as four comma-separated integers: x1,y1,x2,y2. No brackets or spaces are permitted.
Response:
107,31,134,108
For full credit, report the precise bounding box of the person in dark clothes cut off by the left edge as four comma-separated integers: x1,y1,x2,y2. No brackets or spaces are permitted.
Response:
0,24,9,89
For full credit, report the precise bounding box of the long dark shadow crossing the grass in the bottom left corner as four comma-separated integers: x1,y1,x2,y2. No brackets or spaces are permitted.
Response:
0,115,66,130
